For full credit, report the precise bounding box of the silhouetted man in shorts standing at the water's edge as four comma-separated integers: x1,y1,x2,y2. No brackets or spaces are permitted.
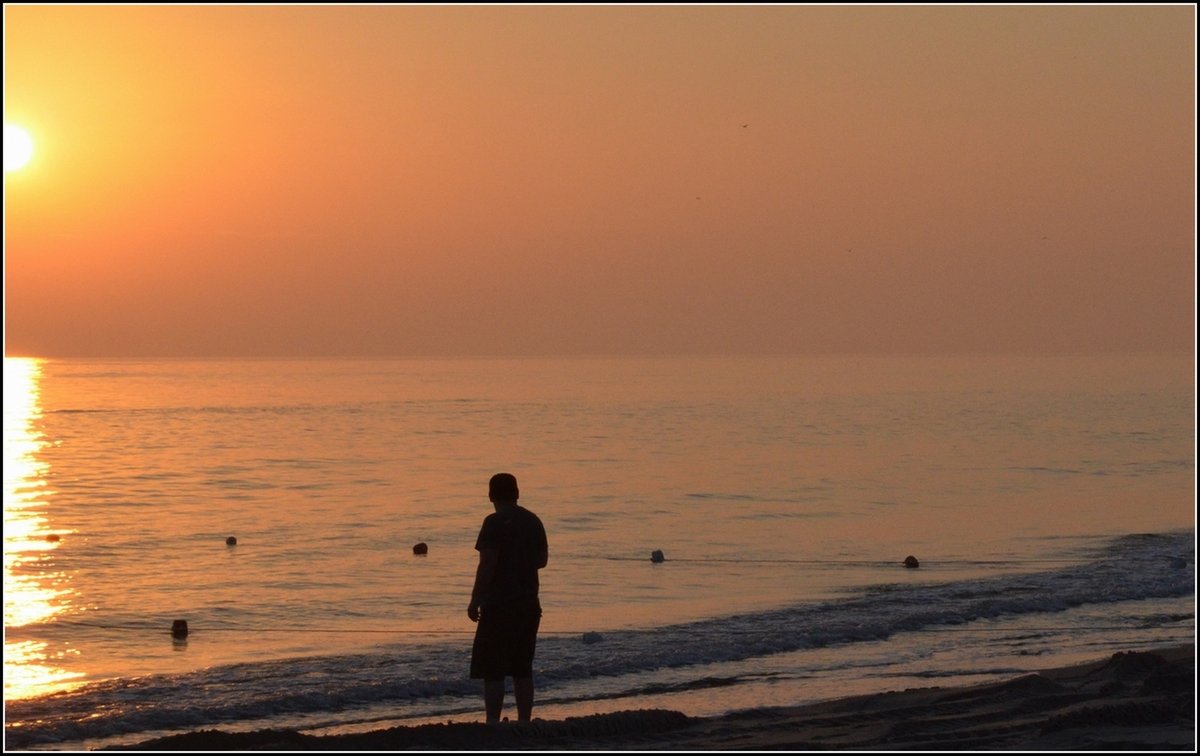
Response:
467,473,550,722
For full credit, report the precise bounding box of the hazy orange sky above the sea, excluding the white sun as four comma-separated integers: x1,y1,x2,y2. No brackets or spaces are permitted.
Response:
4,5,1196,356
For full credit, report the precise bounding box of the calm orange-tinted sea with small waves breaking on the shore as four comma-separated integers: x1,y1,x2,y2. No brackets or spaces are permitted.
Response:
4,354,1196,751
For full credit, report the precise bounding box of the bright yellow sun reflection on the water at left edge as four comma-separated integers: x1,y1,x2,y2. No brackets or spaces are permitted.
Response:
4,358,83,701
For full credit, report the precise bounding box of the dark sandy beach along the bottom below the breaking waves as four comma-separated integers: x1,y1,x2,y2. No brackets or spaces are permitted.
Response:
112,647,1196,751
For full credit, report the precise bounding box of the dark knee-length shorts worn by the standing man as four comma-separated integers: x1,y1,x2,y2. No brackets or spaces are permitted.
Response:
470,598,541,680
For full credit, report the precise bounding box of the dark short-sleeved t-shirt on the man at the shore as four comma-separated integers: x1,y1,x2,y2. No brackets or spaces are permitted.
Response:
475,505,547,606
